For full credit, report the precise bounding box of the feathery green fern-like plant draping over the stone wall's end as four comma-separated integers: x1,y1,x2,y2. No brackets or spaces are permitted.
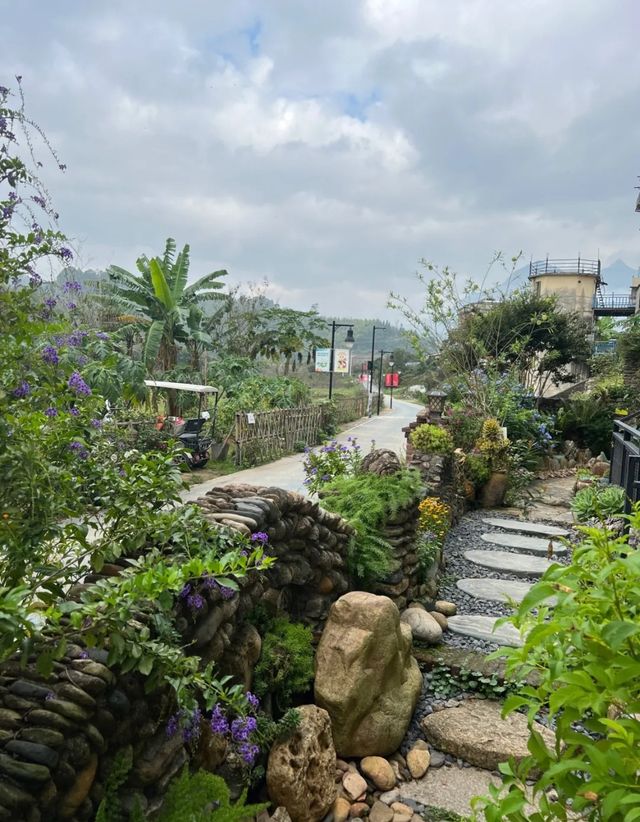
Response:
321,469,422,587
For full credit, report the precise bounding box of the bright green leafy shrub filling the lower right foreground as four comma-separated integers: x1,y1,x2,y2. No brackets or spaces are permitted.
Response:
476,506,640,822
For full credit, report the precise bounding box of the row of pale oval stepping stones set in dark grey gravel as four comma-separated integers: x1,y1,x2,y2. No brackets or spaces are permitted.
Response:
448,517,569,646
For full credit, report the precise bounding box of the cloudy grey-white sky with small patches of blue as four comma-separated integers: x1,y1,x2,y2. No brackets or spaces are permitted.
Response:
0,0,640,316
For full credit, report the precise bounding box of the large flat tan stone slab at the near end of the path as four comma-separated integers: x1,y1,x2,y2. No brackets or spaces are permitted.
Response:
422,699,555,771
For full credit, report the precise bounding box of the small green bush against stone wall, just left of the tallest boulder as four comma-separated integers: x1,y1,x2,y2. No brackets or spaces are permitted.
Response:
254,617,313,711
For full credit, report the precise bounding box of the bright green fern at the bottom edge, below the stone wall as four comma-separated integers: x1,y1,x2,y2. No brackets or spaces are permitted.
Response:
158,767,267,822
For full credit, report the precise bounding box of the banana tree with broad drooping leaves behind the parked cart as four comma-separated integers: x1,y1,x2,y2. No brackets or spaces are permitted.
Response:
108,238,227,371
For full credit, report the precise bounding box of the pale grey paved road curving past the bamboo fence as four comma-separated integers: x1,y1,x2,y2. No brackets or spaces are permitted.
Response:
182,398,421,502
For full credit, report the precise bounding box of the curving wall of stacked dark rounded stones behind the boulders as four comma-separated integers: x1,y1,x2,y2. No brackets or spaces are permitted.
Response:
0,486,420,822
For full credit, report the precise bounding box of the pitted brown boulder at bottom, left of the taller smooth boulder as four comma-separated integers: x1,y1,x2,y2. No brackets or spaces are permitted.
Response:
267,705,337,822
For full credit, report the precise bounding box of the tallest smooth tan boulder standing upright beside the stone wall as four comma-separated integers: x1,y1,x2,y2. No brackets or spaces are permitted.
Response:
315,591,422,757
